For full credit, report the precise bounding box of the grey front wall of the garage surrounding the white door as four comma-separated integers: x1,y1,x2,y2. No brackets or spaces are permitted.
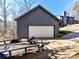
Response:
17,8,59,38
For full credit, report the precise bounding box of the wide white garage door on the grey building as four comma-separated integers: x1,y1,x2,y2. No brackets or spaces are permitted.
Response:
29,26,54,38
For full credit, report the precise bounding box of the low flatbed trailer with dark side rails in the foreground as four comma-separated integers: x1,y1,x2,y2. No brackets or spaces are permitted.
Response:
0,42,47,57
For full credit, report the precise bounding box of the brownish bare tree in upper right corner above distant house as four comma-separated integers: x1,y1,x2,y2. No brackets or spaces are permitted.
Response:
67,0,79,19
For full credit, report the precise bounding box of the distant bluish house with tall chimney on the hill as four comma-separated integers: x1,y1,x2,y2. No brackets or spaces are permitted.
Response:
60,11,74,26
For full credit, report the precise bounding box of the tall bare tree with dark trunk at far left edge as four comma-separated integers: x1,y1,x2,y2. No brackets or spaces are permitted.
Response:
0,0,13,39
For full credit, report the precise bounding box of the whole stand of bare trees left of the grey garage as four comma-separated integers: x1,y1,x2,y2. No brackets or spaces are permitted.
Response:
0,0,36,40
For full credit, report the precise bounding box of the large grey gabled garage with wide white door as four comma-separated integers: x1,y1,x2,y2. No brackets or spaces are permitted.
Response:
15,5,59,38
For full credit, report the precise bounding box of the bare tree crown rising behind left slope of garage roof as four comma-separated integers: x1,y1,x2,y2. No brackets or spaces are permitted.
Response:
16,0,36,13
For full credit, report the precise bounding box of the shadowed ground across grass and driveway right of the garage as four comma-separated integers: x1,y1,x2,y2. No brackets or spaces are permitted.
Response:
58,31,79,39
